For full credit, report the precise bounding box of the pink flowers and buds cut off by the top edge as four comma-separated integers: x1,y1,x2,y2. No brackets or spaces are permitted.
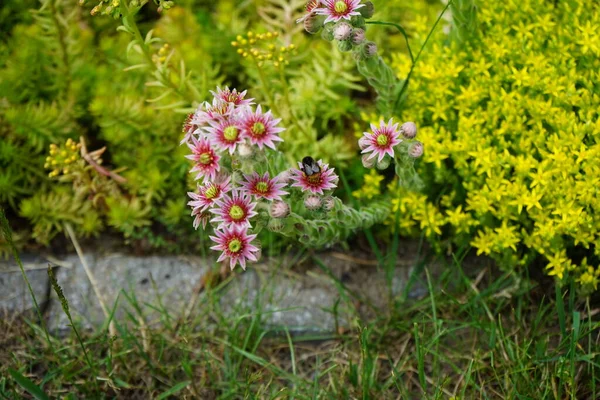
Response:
297,0,377,59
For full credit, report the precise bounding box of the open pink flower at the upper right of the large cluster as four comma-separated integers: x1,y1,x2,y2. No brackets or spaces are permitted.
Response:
241,105,285,150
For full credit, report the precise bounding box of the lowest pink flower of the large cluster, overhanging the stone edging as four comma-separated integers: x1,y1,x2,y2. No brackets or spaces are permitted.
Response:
210,225,258,270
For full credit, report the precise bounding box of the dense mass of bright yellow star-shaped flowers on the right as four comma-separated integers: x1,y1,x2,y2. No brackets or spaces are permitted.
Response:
386,0,600,293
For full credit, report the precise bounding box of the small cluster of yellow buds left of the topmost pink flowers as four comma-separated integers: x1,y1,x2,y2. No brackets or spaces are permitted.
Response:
231,32,296,68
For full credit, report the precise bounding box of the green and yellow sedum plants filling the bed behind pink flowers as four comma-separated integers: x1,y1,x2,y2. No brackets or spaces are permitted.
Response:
0,0,600,292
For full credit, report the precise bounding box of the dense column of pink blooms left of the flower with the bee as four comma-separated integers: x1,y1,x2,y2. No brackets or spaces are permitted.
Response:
182,88,287,269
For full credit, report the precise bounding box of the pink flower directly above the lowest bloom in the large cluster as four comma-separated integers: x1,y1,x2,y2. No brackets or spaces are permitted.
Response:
210,190,257,226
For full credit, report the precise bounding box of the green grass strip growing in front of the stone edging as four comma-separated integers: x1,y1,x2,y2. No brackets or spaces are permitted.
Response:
0,208,600,399
